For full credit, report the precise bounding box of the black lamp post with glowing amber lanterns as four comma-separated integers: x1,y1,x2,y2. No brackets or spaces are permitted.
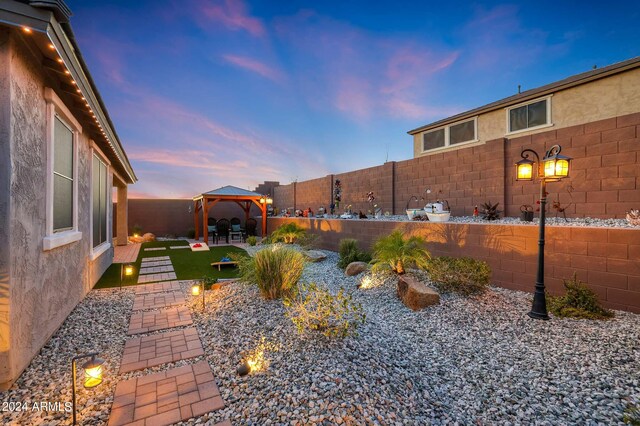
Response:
516,145,571,320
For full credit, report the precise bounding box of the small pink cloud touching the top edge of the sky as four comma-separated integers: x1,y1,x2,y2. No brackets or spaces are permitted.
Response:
194,0,266,37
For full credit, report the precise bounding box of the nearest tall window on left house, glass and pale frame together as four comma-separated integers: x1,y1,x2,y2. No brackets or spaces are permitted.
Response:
42,88,82,250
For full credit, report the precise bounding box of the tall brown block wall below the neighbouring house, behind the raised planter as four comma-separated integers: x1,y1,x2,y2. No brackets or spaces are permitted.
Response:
274,113,640,218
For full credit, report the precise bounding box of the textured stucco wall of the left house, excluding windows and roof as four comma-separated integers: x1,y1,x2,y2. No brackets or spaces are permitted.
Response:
0,29,113,388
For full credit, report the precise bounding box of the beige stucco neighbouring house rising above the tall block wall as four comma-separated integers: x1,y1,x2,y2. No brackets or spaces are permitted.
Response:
408,57,640,158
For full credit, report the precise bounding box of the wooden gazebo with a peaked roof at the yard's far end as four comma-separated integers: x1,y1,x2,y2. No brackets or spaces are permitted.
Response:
193,185,271,242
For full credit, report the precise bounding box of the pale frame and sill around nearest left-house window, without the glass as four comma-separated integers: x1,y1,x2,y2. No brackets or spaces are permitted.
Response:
42,87,82,251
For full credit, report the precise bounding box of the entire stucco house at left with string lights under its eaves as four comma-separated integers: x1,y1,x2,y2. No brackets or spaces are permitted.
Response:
0,0,137,389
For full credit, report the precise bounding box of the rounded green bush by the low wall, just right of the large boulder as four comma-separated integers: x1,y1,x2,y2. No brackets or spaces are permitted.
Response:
427,256,491,296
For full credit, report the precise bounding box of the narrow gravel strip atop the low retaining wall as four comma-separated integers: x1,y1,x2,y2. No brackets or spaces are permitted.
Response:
280,215,640,229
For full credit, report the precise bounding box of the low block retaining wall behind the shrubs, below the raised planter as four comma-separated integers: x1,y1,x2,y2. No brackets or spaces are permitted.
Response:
267,217,640,313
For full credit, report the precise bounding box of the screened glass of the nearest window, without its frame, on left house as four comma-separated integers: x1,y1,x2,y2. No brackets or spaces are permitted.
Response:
53,116,73,231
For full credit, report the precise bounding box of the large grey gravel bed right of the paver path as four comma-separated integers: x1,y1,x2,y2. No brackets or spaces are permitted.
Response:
183,247,640,425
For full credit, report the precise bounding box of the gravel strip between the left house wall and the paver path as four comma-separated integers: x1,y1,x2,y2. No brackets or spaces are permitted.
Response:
0,287,134,425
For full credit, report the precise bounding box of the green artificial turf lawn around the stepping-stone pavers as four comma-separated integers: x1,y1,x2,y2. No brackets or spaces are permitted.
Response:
94,240,247,288
